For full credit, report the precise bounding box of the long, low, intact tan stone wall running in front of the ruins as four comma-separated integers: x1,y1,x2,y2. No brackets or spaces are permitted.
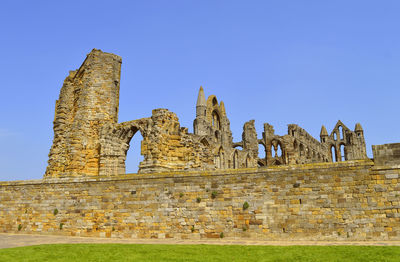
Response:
0,160,400,240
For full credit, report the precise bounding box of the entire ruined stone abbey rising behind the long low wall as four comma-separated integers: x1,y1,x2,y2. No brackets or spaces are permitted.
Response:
45,49,367,177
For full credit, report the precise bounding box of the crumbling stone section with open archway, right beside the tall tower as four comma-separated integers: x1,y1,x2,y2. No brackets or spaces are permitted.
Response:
100,109,214,175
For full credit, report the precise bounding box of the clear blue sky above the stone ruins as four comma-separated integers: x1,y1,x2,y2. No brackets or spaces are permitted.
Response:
0,0,400,181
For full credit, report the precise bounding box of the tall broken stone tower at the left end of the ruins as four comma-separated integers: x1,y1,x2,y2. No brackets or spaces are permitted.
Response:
45,49,122,177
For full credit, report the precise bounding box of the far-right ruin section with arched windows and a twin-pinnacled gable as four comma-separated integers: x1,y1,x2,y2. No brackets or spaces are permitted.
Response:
259,120,368,166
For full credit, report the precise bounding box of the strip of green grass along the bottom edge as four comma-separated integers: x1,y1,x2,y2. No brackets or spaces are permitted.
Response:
0,244,400,262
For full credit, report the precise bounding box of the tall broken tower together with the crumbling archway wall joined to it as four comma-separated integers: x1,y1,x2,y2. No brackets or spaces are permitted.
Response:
45,49,225,178
